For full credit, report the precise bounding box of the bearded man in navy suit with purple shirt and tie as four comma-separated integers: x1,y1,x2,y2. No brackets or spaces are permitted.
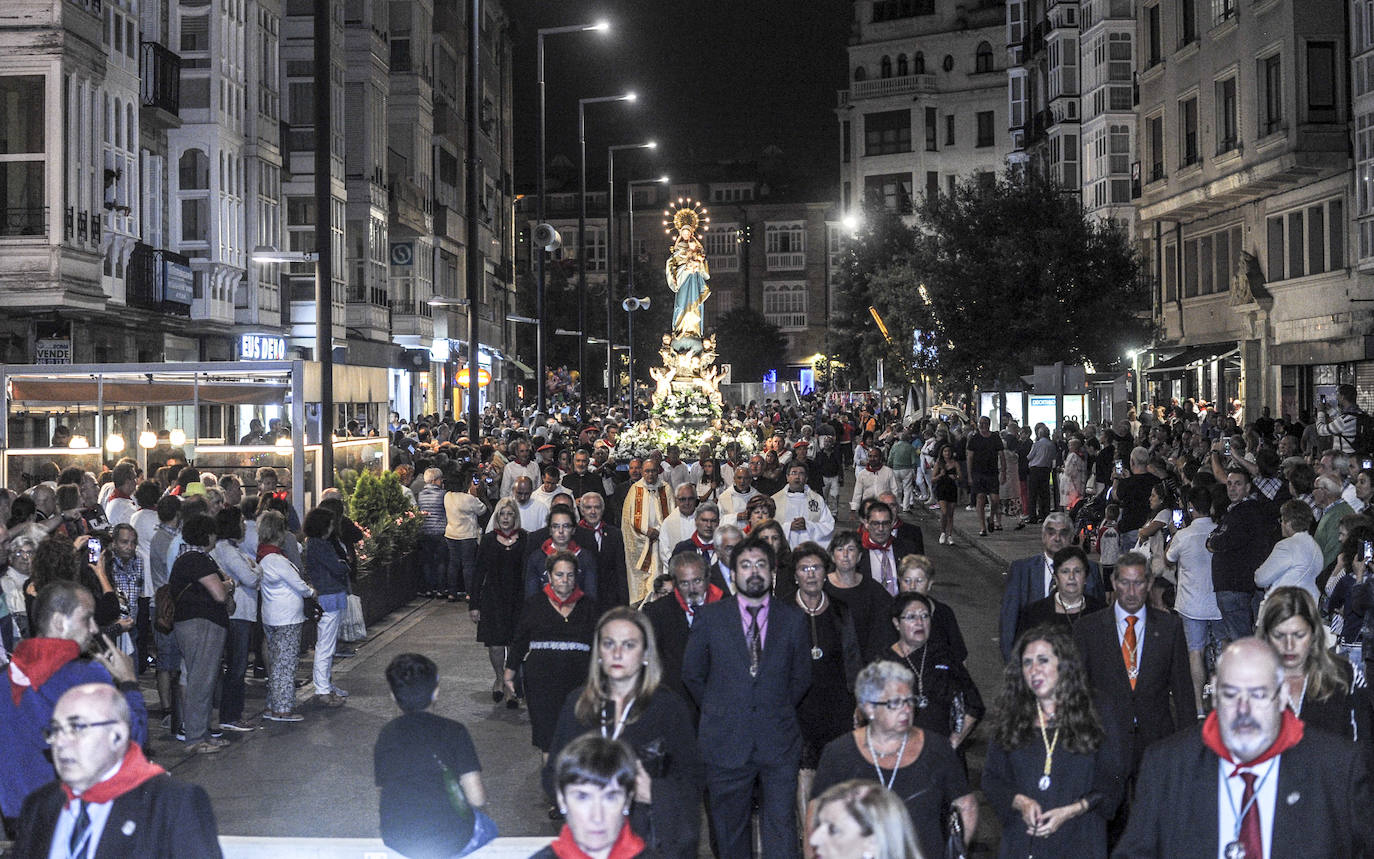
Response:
683,537,811,859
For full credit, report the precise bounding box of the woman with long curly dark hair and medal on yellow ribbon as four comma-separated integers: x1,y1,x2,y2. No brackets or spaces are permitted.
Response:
982,627,1124,859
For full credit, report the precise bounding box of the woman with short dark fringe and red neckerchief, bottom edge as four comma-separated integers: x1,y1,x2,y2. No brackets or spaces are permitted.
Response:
530,734,651,859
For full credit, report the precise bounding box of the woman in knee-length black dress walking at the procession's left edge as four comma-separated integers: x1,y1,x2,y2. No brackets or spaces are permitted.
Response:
478,498,528,709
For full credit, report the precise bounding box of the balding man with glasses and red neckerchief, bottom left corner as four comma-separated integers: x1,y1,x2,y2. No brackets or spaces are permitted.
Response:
14,683,220,859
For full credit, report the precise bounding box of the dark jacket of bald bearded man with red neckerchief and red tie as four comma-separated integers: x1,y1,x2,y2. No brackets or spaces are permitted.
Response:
1112,726,1374,859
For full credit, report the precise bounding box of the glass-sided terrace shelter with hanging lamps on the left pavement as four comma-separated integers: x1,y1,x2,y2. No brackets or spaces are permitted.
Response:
0,360,390,510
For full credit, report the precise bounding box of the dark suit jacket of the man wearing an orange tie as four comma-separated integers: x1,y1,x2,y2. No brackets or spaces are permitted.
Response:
1073,606,1197,772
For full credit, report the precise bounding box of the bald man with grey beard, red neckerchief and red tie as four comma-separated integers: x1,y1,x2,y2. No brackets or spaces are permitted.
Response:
1115,637,1374,859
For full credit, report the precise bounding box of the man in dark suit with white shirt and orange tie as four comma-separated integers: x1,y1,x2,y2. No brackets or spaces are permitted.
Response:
1073,553,1198,836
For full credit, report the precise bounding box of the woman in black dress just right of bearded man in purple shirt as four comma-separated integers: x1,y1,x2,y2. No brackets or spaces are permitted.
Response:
791,540,863,816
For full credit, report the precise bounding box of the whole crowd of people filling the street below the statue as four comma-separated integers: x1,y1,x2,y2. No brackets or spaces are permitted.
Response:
8,386,1374,859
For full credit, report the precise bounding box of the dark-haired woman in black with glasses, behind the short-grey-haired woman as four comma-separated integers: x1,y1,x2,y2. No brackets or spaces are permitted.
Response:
886,591,985,750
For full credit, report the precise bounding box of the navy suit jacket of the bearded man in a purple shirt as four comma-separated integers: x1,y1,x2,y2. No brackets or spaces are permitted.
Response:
683,596,811,768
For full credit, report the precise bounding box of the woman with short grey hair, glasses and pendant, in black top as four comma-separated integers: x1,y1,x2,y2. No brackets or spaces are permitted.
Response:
805,660,978,856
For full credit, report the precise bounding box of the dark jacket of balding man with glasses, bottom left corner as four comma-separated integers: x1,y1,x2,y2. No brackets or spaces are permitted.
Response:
14,774,221,859
